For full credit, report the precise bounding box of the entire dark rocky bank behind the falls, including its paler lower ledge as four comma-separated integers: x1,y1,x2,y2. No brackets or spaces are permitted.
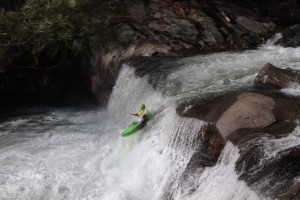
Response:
93,0,277,103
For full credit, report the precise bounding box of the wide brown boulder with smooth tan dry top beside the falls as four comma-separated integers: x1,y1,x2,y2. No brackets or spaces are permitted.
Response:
177,92,300,143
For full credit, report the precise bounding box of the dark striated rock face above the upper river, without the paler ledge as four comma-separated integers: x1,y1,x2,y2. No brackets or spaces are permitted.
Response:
147,0,275,52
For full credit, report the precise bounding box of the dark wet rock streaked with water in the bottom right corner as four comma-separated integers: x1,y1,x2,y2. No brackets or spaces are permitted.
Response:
236,142,300,199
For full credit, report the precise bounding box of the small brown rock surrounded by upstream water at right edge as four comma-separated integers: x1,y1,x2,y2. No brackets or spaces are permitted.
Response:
254,63,300,88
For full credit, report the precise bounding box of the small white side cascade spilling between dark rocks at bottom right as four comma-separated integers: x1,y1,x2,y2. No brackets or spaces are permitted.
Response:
176,142,267,200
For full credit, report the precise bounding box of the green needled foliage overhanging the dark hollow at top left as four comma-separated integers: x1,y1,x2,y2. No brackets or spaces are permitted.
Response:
0,0,141,70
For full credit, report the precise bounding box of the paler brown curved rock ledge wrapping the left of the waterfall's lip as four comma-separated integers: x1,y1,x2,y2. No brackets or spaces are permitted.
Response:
91,39,172,105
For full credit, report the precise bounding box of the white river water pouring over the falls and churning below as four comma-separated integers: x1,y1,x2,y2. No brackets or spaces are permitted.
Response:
0,38,300,200
